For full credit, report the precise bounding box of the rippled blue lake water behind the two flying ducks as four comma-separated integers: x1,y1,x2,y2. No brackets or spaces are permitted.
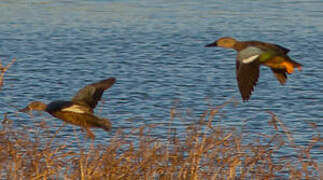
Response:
0,0,323,162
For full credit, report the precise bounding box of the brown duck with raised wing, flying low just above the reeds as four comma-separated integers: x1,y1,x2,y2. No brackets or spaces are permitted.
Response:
19,77,116,139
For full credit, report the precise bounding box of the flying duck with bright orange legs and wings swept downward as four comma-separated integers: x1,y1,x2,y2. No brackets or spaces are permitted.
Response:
205,37,302,101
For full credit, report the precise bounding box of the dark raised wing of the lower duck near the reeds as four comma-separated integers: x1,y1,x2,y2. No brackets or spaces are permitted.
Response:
72,77,116,109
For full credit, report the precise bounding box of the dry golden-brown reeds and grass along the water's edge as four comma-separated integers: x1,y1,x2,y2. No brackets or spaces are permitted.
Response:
0,60,323,180
